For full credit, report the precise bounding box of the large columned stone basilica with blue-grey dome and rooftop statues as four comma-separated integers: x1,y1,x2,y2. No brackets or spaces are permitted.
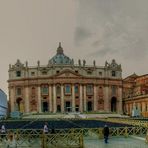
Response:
8,44,122,113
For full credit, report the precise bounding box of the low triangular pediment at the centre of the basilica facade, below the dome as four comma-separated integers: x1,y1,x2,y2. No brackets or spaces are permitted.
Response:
55,70,82,78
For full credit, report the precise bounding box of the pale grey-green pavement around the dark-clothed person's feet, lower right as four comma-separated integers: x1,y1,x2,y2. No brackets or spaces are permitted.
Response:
84,137,148,148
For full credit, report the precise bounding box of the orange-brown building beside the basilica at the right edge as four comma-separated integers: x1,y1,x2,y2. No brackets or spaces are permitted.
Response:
123,74,148,117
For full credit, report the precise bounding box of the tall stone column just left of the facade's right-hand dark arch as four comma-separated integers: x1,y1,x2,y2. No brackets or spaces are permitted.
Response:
104,86,110,112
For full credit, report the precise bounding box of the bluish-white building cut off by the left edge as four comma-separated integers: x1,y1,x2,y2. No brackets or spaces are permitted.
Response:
0,89,8,117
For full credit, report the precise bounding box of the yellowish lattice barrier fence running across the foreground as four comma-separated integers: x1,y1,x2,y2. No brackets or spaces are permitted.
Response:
1,127,148,148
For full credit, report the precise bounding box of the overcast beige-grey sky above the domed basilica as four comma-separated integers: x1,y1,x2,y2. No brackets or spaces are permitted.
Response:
0,0,148,93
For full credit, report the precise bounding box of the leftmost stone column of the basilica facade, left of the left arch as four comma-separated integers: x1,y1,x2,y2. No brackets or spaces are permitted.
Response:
10,87,16,112
